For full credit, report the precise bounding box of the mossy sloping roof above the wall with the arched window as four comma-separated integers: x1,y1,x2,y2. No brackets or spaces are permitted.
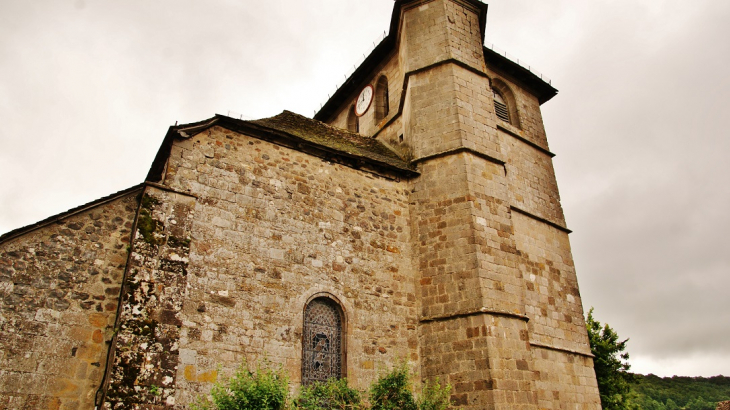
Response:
246,111,414,171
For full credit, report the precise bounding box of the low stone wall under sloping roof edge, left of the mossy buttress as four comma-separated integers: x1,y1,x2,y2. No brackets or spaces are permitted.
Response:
0,192,139,409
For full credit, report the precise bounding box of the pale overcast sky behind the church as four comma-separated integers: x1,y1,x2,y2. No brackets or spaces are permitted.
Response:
0,0,730,376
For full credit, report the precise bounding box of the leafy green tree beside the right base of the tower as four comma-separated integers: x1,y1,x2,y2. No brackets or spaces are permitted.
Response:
586,308,632,410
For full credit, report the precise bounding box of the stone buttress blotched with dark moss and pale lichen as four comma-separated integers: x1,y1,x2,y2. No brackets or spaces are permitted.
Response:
104,186,195,409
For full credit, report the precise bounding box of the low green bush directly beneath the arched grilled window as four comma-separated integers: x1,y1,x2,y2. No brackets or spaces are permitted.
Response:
295,379,362,410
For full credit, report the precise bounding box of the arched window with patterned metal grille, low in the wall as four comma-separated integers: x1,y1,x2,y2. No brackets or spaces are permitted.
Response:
302,297,345,386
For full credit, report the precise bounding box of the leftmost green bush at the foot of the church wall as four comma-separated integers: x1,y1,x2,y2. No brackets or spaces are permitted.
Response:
192,362,289,410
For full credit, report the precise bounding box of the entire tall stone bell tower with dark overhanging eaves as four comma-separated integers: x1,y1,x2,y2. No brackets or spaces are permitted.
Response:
315,0,600,409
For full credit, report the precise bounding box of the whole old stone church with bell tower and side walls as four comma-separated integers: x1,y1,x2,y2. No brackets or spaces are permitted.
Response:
0,0,601,410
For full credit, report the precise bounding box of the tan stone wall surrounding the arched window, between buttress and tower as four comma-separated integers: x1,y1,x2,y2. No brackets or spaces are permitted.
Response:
164,127,419,403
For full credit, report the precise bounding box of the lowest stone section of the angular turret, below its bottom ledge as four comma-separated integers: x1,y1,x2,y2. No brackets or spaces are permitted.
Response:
420,313,537,409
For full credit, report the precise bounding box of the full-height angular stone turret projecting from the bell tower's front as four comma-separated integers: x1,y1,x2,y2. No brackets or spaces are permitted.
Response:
399,0,537,409
